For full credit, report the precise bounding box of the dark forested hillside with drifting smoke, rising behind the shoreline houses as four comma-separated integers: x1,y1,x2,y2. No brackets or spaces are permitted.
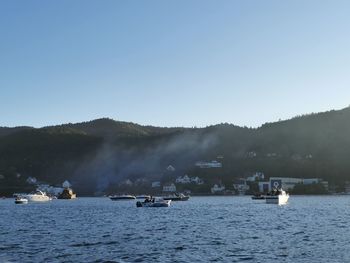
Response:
0,108,350,194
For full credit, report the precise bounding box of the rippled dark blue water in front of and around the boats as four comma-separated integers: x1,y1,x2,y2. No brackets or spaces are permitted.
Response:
0,196,350,263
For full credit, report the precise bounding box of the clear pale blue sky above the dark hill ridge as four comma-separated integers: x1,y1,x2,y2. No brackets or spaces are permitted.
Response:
0,0,350,127
